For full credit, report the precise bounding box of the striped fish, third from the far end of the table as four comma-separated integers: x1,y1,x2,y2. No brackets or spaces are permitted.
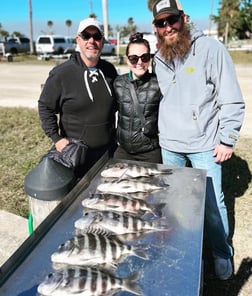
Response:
82,193,165,216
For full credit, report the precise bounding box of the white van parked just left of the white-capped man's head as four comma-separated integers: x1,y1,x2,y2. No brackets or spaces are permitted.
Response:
35,35,76,55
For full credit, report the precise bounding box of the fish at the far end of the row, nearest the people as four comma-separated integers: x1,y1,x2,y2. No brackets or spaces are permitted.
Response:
101,163,171,180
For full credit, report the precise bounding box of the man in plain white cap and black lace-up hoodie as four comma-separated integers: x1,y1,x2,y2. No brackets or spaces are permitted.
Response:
38,18,117,177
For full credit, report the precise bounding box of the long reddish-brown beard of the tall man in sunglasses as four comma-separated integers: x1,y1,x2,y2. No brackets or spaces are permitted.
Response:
158,26,191,62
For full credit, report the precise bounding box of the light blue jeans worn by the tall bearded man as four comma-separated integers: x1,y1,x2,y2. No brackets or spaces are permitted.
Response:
161,148,233,259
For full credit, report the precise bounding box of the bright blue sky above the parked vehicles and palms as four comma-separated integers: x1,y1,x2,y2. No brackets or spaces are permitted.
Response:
0,0,219,39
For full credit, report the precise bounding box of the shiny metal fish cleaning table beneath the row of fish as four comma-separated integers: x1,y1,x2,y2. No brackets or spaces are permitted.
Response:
0,159,206,296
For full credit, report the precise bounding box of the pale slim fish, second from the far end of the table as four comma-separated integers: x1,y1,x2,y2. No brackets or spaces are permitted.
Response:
97,180,167,193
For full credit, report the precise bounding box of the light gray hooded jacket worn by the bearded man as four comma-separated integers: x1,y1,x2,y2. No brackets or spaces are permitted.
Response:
153,31,245,153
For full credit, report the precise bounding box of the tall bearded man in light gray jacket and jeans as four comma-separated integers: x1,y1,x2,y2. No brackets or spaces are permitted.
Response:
153,0,244,280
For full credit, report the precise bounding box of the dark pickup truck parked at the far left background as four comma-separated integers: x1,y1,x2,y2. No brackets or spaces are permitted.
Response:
0,37,30,55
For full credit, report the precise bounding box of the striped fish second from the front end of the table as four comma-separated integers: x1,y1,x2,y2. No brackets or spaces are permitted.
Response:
51,233,148,269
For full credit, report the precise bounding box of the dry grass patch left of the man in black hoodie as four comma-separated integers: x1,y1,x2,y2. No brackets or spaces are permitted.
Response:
0,107,51,217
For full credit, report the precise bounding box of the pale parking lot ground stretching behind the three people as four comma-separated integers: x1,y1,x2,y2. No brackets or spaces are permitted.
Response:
0,62,252,136
